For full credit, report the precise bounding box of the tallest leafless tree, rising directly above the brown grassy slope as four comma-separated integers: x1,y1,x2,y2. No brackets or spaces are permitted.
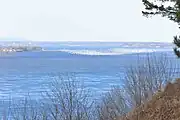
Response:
123,54,179,107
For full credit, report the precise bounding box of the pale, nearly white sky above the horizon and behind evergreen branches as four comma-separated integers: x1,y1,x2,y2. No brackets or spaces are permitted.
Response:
0,0,179,42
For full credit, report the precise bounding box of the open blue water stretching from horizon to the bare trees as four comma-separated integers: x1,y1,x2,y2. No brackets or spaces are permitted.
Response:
0,42,175,99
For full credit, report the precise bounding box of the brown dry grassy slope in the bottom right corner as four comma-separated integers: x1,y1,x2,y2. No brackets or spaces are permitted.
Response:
119,79,180,120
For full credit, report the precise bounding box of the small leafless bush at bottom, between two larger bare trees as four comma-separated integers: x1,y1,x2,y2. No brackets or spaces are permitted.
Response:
96,86,129,120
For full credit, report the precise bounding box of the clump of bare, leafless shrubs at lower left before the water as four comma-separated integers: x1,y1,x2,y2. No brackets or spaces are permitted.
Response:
2,74,94,120
